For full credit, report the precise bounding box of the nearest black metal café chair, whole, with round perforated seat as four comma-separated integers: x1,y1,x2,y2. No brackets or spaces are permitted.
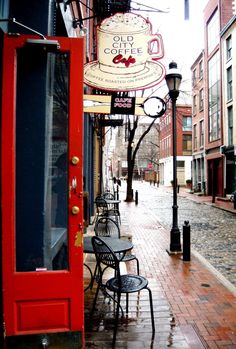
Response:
92,236,155,346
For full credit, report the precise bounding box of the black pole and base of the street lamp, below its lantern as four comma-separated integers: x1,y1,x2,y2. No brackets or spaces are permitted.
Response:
170,96,181,252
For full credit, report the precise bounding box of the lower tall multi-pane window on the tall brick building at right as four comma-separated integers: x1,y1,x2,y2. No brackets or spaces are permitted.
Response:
208,51,221,142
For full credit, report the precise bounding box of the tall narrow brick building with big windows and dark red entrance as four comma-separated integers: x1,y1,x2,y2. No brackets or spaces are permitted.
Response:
204,0,233,198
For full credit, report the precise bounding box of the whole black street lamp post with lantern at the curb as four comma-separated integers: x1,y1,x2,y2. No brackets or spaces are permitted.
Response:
165,62,182,254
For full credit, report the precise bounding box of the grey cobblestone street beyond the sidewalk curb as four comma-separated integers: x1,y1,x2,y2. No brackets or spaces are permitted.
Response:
121,181,236,286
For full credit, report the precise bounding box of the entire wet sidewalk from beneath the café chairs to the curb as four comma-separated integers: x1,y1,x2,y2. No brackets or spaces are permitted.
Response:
85,186,236,349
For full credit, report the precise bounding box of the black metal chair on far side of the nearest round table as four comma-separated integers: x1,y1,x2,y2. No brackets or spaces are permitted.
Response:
94,217,139,275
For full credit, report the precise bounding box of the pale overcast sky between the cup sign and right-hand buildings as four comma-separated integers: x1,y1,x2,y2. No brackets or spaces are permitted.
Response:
132,0,207,101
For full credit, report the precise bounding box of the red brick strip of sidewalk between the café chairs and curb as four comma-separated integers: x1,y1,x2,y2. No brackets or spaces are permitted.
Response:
123,201,236,348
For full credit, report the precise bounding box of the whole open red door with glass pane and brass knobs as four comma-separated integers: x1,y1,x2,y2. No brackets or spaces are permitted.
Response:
1,35,84,348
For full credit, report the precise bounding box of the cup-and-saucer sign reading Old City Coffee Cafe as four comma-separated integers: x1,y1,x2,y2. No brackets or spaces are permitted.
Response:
84,13,165,91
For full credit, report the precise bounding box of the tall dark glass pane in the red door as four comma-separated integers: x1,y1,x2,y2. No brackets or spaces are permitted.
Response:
15,48,69,271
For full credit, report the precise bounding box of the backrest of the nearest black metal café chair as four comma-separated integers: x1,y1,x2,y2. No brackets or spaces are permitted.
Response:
92,236,120,278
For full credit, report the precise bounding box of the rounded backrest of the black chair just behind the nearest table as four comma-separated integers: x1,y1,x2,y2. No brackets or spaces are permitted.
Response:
94,217,120,239
